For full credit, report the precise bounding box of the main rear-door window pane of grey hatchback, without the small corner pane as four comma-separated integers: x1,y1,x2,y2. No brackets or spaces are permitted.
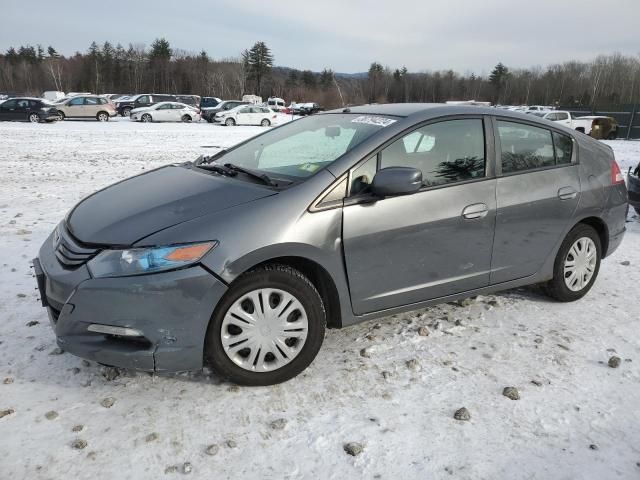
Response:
498,120,556,173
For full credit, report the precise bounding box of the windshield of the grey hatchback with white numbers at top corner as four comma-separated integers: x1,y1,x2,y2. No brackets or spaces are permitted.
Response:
210,114,397,181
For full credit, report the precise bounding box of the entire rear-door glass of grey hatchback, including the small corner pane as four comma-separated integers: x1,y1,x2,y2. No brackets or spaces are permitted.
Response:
498,121,573,173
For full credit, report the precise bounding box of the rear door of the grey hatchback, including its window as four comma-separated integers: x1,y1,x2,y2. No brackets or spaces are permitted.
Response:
491,119,580,284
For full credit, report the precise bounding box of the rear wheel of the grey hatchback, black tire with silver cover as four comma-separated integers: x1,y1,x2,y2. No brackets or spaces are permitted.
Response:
543,223,602,302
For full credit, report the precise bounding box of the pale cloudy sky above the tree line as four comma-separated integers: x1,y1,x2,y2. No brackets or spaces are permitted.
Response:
0,0,640,74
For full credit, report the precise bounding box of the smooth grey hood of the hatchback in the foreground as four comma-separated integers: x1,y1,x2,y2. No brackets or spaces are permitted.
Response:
67,166,276,246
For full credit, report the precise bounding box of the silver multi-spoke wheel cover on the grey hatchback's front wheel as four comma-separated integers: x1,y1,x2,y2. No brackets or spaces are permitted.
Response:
220,288,309,372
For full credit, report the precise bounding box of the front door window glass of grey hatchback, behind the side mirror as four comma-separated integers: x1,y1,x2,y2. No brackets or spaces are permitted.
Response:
380,119,485,186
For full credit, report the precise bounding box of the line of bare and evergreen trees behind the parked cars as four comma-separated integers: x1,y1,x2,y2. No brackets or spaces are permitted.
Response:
0,38,640,107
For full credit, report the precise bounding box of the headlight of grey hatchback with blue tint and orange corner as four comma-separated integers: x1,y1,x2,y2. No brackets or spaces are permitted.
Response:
87,242,217,277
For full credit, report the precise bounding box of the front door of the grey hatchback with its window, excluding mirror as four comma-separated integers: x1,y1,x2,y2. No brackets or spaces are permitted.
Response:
343,117,496,315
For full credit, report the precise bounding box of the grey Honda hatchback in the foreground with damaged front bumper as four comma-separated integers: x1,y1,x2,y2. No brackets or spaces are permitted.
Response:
33,104,628,385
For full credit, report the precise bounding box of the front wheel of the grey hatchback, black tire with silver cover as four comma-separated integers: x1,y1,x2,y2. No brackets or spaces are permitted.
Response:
205,265,326,386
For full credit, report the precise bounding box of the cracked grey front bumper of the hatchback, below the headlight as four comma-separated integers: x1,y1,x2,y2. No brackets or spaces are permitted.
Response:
34,231,226,372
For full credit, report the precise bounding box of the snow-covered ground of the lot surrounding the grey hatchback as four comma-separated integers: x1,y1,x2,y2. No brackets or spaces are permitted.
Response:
0,121,640,480
